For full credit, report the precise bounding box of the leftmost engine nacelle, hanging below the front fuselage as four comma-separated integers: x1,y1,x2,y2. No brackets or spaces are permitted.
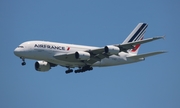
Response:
34,61,51,72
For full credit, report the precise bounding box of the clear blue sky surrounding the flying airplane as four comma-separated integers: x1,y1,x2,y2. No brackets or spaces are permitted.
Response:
0,0,180,108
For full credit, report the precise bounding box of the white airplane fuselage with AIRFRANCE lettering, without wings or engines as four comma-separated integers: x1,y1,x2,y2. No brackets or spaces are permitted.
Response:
14,41,142,67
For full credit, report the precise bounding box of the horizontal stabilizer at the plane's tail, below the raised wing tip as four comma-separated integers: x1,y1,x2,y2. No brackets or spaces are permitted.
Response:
127,51,166,59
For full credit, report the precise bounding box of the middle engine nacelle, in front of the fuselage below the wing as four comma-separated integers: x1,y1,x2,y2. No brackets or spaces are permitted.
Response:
75,51,91,60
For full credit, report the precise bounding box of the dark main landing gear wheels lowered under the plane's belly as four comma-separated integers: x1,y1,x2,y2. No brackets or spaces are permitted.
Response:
65,65,93,74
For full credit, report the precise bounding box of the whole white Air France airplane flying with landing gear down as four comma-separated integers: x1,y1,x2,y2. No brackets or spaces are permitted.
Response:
14,23,166,74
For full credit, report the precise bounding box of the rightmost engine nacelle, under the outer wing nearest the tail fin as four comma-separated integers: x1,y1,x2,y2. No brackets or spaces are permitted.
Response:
104,46,120,54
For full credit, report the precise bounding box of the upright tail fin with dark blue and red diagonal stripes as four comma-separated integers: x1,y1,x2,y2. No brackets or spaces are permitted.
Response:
123,23,148,54
